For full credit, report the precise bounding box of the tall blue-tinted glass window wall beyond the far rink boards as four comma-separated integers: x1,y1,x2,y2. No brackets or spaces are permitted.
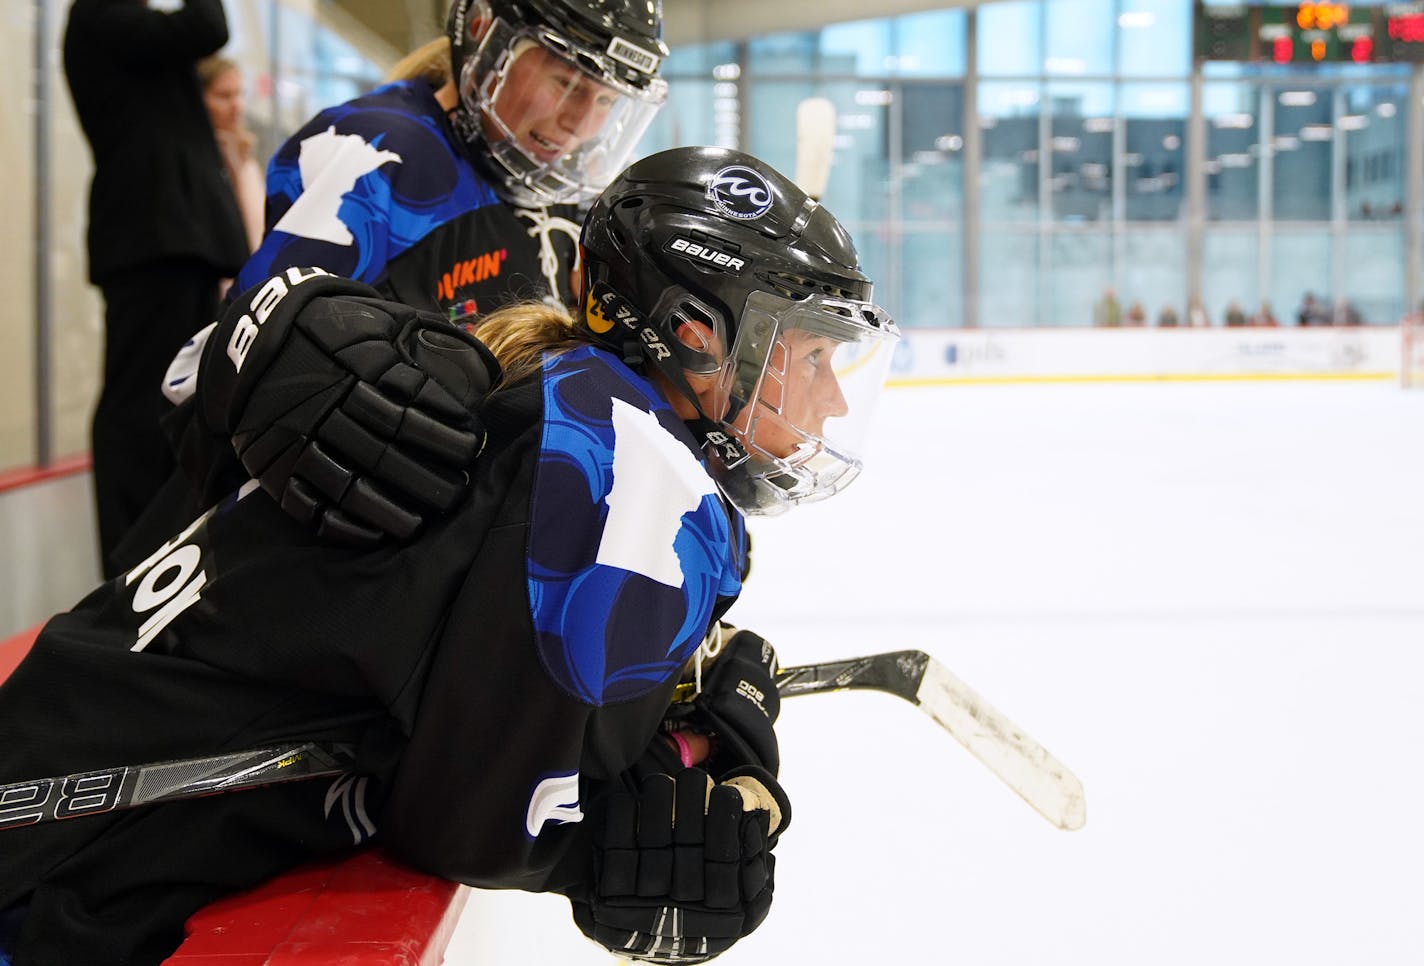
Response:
652,0,1424,326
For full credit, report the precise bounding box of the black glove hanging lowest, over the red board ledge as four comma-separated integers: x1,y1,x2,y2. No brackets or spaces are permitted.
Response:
571,768,790,963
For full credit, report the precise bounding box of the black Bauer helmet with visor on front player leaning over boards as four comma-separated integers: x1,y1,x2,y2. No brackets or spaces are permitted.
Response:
580,148,899,514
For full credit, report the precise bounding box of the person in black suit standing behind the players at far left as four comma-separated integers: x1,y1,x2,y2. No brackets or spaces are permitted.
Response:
64,0,248,577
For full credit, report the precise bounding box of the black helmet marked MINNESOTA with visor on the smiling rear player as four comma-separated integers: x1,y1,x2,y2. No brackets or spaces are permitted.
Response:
446,0,668,205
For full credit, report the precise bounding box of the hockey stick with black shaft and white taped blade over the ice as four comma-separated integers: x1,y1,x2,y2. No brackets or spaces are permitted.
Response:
776,651,1088,831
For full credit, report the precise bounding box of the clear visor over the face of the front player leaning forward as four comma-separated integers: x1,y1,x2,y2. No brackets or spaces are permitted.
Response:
708,292,899,514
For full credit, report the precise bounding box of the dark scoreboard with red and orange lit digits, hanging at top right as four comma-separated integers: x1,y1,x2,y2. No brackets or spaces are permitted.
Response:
1193,0,1424,64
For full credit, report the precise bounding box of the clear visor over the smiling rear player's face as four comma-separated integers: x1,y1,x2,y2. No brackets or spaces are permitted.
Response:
460,20,668,204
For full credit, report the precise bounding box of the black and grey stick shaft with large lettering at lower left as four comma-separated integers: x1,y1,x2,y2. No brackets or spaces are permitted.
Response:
0,741,356,829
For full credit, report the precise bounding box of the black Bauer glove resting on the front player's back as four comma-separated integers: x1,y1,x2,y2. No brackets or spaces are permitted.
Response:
198,269,500,546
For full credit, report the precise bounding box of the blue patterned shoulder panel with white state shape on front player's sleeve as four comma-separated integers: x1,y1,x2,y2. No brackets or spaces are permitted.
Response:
528,348,740,705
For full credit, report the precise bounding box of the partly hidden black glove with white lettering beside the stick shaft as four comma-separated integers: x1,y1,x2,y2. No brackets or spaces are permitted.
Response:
668,628,782,779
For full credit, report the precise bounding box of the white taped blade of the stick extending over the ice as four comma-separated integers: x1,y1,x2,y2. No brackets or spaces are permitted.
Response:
916,658,1088,831
